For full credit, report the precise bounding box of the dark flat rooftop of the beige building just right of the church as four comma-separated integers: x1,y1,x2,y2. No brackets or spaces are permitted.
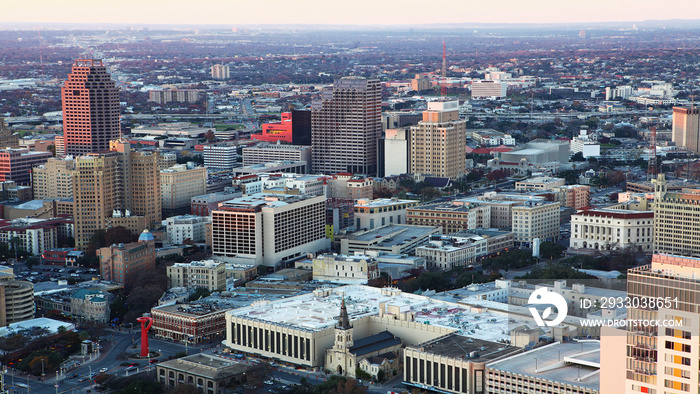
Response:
413,334,522,363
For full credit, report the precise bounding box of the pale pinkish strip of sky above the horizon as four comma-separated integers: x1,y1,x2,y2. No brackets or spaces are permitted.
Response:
0,0,700,26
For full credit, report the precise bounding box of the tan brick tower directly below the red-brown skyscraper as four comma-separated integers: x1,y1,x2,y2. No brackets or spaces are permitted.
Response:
73,152,118,249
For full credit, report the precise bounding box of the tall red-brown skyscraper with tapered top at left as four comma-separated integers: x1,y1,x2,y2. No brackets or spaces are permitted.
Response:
61,59,121,155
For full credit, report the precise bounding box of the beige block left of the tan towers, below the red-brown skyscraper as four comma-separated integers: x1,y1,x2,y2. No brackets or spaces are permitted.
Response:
32,156,76,200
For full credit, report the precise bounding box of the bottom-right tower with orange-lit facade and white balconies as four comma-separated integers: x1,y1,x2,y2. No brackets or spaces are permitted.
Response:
624,254,700,394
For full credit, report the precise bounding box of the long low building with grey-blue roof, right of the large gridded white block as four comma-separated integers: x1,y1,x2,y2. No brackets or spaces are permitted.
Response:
340,224,440,255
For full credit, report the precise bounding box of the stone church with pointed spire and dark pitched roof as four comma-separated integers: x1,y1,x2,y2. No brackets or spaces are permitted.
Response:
326,299,403,378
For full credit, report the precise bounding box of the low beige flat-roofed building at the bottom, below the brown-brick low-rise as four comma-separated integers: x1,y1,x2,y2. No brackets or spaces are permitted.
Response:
156,353,257,394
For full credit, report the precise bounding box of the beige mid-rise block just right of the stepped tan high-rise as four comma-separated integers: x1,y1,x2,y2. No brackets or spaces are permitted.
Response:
160,164,207,216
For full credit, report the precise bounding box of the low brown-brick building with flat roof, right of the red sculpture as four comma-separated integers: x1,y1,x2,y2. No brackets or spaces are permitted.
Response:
151,303,226,344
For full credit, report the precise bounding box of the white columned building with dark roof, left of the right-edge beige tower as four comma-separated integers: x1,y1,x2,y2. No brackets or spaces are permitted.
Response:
569,209,654,253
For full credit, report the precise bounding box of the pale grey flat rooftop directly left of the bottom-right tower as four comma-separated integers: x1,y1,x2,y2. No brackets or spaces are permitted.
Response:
487,340,600,390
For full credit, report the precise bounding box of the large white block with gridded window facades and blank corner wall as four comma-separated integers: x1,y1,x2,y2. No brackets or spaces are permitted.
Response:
212,193,330,267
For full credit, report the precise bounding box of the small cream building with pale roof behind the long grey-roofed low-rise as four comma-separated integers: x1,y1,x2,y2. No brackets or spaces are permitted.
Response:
353,198,418,230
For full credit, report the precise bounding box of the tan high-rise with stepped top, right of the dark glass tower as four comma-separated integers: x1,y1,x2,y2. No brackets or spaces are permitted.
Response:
408,101,467,179
